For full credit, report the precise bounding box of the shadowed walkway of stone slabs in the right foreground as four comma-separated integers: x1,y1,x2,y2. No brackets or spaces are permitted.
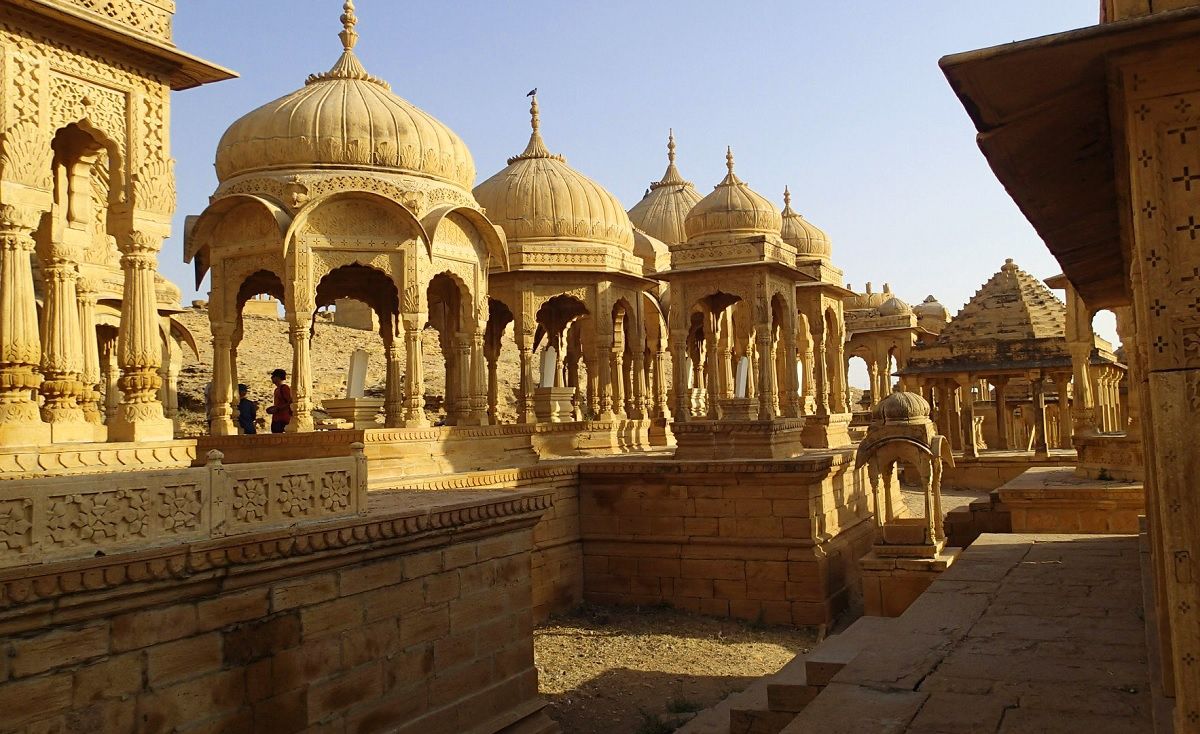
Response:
784,535,1151,734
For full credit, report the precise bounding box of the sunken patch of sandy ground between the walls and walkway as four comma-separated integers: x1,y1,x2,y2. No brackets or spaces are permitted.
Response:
534,606,816,734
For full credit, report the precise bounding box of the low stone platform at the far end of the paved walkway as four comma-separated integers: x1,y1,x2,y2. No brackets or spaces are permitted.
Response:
946,467,1146,547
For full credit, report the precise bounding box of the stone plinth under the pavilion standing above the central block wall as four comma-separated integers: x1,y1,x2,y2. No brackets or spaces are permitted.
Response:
671,419,810,461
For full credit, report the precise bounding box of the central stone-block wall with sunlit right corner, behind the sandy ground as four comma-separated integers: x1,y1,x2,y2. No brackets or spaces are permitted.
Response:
580,451,872,625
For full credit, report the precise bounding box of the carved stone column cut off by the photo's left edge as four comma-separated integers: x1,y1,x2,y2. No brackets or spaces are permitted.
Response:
0,204,50,446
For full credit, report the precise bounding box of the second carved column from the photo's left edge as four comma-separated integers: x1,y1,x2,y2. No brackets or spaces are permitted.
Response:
41,242,88,443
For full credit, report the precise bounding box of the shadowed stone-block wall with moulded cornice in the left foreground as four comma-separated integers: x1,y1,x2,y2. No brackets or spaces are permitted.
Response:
0,492,557,734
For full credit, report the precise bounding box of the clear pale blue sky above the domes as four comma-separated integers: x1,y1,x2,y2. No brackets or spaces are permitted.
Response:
169,0,1109,383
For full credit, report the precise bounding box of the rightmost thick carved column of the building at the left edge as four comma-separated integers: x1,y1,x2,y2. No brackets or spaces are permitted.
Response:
108,230,174,441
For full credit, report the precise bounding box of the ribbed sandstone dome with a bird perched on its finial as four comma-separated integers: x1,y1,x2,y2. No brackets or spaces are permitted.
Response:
475,97,634,252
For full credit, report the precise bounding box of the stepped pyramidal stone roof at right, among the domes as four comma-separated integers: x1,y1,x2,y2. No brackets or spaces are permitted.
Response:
938,258,1067,343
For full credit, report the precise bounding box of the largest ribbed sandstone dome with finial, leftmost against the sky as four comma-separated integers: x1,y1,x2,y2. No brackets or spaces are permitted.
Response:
216,2,475,189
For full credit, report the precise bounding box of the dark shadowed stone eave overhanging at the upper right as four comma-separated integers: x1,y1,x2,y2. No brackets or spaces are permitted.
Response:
940,7,1200,308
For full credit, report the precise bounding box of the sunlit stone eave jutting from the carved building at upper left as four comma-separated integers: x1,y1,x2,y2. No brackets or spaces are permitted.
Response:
8,0,238,91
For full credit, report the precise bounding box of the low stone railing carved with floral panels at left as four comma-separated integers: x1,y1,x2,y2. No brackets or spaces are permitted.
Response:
0,443,367,568
